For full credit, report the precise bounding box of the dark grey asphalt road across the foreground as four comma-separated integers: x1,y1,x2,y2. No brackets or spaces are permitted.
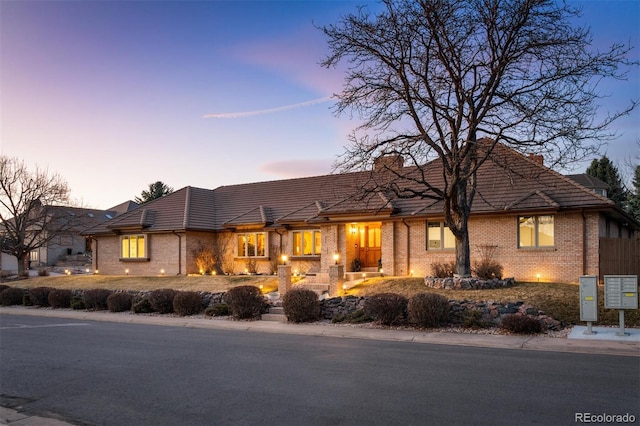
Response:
0,315,640,425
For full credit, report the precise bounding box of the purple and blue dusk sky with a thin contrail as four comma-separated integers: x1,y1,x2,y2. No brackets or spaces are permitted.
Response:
0,0,640,209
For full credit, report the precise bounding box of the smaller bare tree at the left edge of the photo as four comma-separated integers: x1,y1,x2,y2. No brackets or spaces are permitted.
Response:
0,156,74,274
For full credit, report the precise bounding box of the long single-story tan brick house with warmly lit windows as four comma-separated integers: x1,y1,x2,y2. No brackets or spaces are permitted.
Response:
84,146,640,282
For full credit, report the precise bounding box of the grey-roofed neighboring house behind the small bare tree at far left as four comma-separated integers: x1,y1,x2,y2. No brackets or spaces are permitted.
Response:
0,201,138,272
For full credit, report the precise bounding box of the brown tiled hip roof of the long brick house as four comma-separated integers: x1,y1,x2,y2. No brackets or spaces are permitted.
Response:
85,145,640,235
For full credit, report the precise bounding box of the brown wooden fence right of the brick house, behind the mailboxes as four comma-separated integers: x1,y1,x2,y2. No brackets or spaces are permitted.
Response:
600,238,640,280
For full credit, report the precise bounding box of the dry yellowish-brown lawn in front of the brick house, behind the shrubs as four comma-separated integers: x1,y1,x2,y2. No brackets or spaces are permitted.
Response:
2,275,640,327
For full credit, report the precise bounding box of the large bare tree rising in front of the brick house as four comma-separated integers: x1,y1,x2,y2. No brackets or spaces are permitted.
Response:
321,0,637,275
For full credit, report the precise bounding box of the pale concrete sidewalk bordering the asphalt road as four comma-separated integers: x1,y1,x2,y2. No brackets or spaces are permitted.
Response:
0,308,640,426
